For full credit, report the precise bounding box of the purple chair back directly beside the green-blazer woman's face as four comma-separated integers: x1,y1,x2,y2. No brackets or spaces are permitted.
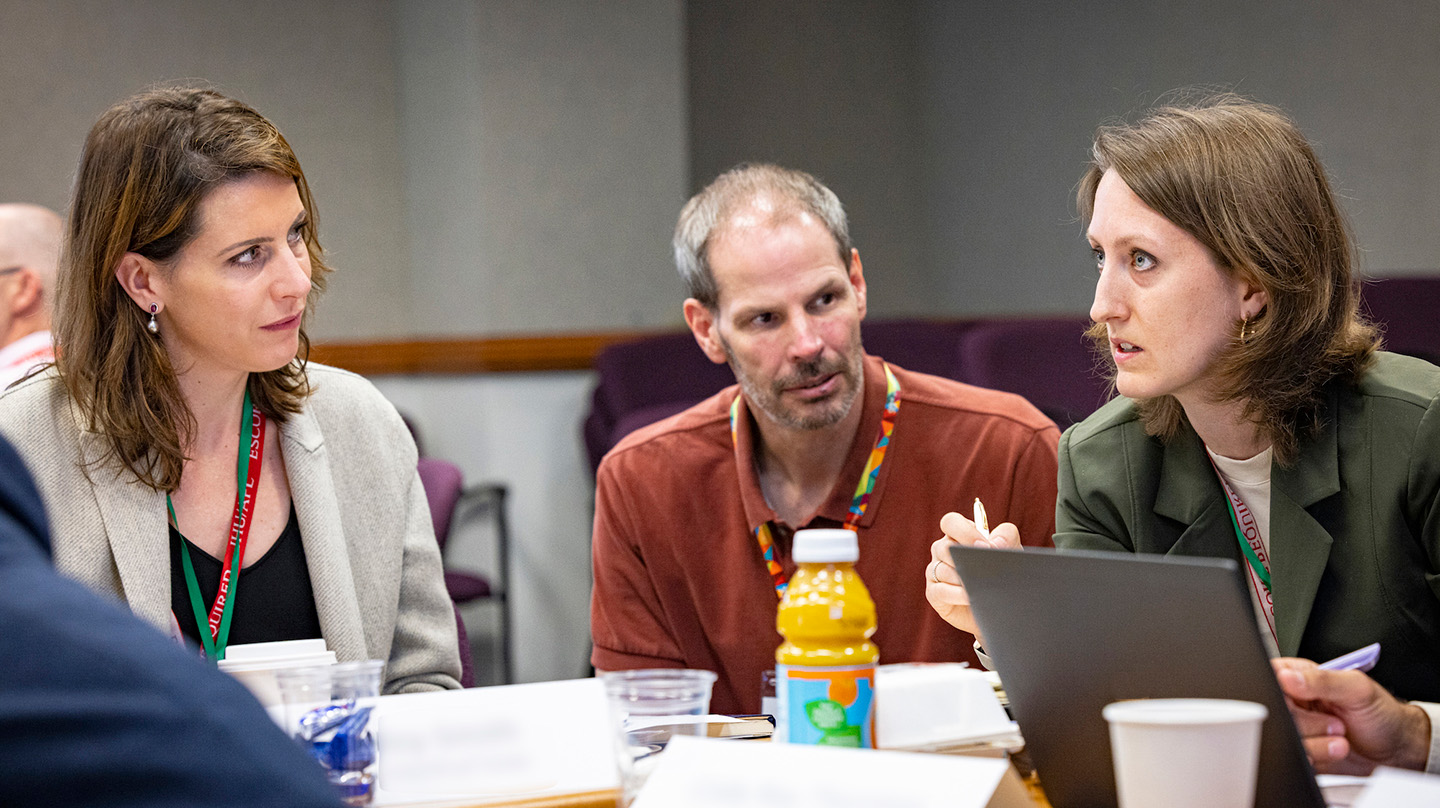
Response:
960,317,1110,429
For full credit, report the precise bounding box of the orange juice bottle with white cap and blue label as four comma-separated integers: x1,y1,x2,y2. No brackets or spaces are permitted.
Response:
775,530,880,749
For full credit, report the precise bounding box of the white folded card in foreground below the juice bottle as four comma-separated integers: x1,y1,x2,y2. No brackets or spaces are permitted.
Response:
632,736,1031,808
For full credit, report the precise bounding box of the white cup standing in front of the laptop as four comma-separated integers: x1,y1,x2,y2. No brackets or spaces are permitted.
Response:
1103,699,1269,808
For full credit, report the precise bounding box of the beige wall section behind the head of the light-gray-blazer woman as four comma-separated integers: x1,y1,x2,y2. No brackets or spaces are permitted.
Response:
0,0,416,337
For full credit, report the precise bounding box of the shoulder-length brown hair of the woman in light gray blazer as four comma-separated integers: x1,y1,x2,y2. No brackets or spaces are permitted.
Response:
55,86,330,491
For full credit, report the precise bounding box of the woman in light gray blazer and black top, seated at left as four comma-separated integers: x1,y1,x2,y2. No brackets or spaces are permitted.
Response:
0,88,459,693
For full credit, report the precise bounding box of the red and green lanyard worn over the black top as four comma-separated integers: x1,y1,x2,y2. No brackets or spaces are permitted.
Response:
166,390,265,663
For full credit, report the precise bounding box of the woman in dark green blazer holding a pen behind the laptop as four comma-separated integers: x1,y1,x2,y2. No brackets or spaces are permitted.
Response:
927,96,1440,766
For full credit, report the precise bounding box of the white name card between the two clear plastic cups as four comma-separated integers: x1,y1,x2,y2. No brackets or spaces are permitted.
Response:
376,678,619,805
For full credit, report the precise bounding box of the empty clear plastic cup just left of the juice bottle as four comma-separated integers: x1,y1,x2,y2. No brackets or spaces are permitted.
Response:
600,668,716,807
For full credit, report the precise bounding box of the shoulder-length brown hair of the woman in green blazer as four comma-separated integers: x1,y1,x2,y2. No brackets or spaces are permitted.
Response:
1077,94,1378,464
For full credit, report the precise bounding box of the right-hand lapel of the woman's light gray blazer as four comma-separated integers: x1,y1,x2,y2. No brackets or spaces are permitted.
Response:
279,410,370,661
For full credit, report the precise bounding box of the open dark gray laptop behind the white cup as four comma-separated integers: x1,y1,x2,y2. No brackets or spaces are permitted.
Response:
950,544,1325,808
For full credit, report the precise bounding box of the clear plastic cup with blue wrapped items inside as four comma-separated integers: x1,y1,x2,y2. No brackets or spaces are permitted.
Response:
275,660,384,805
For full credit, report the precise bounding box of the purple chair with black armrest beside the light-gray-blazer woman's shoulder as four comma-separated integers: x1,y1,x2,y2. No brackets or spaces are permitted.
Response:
419,457,510,687
